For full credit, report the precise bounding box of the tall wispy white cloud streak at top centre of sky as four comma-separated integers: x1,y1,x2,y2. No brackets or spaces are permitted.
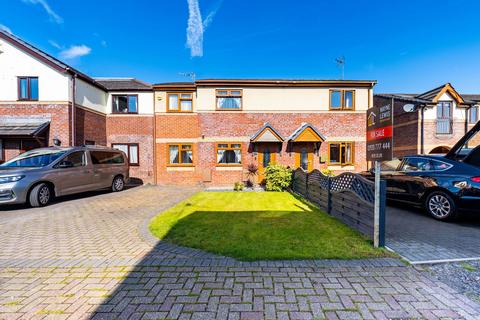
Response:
186,0,223,57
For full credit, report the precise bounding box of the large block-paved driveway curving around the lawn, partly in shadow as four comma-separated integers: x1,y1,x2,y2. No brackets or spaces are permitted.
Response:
0,186,480,319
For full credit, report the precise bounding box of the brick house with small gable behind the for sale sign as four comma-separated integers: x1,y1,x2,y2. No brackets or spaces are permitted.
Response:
373,83,480,157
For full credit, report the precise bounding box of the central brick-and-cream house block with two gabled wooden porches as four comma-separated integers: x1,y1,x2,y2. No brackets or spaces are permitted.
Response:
153,79,375,185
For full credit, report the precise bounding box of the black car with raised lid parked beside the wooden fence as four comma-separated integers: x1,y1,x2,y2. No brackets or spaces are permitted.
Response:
365,122,480,220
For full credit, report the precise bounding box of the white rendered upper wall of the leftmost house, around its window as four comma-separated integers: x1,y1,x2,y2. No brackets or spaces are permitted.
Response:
0,39,70,102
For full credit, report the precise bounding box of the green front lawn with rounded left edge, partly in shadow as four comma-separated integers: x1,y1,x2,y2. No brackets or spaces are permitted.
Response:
150,192,389,260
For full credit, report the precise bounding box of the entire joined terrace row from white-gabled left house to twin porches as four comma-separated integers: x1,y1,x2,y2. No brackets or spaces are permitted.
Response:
0,31,375,185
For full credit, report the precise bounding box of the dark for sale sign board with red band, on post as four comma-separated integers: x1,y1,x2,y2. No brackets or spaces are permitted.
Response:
367,104,393,161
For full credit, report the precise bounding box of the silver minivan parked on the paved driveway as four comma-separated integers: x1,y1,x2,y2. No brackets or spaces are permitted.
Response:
0,146,129,207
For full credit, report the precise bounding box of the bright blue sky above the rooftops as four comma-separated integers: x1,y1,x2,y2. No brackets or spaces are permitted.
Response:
0,0,480,93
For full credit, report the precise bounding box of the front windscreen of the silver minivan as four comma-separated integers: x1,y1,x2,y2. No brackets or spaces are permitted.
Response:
0,149,67,168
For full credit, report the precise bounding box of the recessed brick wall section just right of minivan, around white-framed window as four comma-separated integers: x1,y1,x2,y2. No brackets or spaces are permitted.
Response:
106,115,154,183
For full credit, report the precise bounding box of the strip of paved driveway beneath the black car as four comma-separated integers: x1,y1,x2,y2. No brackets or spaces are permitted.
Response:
386,204,480,264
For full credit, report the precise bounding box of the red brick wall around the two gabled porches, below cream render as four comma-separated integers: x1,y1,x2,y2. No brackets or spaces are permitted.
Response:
156,112,367,185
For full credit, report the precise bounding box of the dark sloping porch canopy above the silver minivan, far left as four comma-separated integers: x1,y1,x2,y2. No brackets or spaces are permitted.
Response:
0,120,50,138
